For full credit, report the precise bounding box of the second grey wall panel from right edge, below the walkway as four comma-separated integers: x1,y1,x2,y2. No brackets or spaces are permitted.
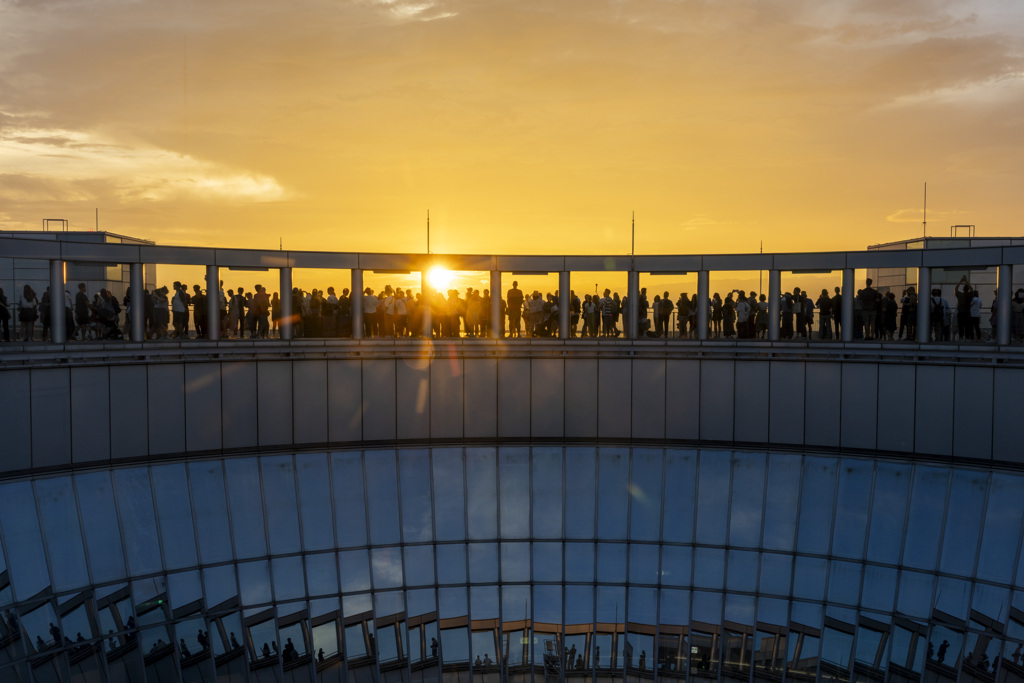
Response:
953,366,991,460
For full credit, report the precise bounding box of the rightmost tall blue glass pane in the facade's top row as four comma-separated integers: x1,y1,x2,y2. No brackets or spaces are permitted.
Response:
978,472,1024,584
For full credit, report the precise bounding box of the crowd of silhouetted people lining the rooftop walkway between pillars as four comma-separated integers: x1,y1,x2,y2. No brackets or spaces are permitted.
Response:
0,276,1024,342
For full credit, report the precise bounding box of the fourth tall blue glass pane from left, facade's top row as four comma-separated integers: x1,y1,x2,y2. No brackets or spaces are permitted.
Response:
114,467,161,577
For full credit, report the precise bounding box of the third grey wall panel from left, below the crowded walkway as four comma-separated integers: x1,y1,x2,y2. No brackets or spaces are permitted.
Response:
71,366,111,464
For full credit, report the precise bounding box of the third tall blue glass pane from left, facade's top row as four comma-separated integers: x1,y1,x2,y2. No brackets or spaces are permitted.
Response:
74,472,125,583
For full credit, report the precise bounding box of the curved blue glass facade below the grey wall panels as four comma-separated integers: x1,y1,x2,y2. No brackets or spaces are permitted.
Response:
0,445,1024,683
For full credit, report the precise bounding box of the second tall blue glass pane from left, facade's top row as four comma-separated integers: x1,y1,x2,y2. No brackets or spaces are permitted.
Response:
36,477,89,591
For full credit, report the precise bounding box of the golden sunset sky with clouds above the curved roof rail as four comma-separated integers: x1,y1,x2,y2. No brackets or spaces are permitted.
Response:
0,0,1024,259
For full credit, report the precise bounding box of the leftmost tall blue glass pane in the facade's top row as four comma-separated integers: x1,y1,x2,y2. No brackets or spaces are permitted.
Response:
0,481,50,600
